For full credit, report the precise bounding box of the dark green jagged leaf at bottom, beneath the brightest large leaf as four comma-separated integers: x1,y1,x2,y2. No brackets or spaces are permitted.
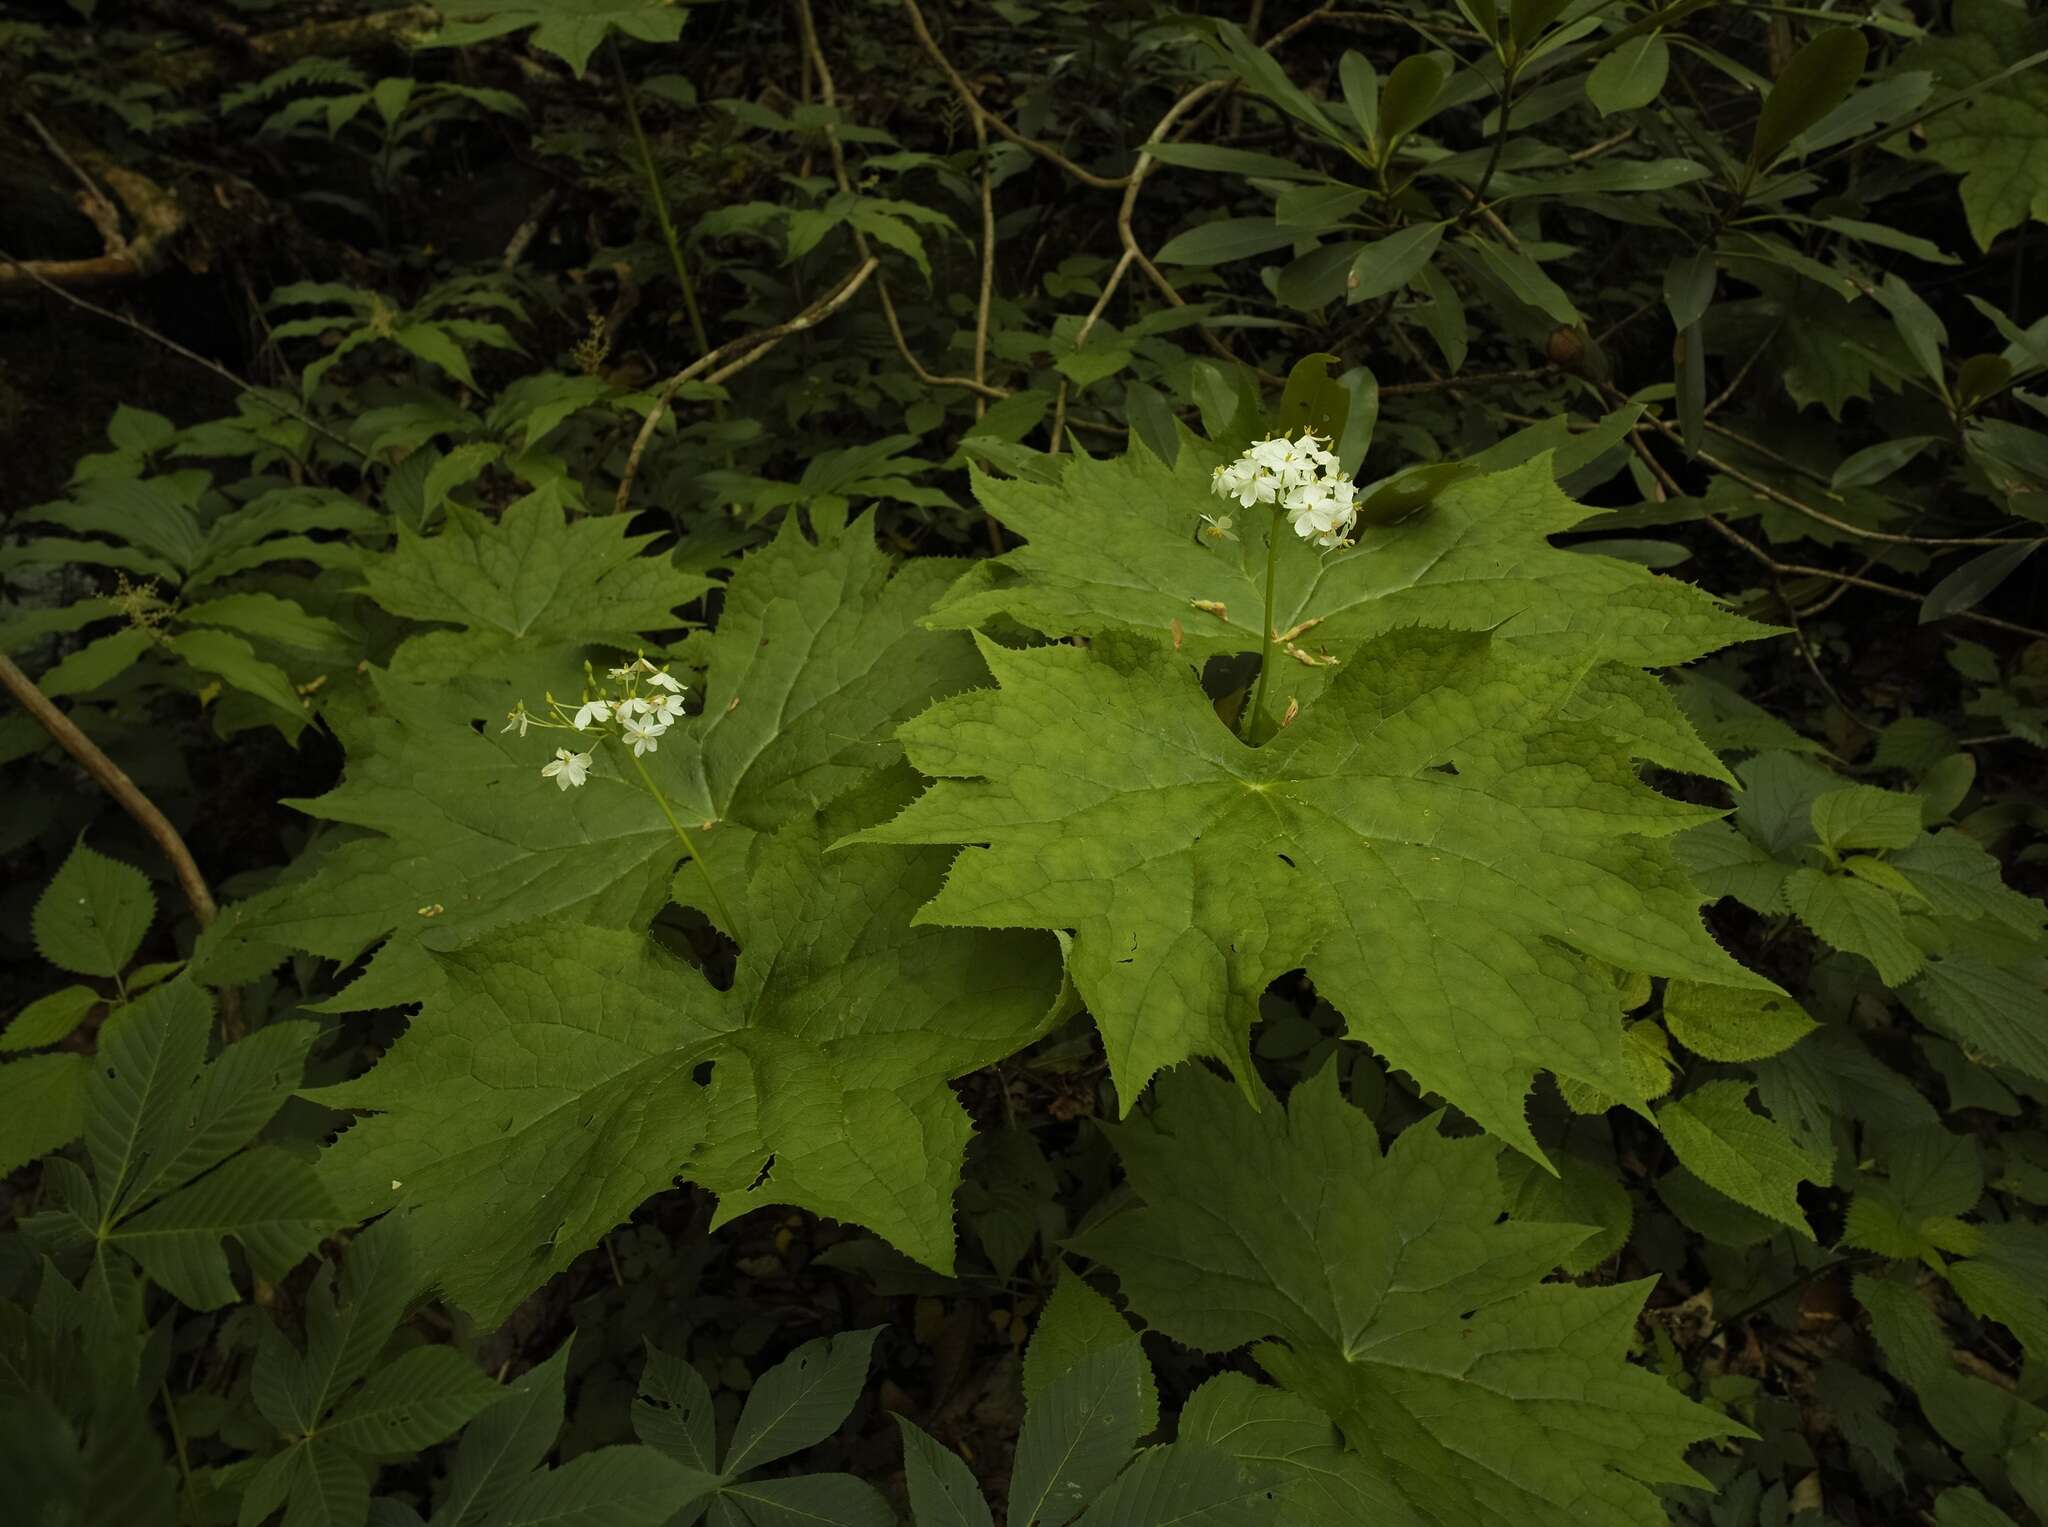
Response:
1075,1068,1741,1527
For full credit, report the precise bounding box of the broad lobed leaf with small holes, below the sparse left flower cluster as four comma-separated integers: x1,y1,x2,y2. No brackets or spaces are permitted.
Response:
319,780,1061,1318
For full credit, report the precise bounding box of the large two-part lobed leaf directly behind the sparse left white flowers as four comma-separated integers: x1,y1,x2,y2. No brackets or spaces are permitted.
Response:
201,520,981,1011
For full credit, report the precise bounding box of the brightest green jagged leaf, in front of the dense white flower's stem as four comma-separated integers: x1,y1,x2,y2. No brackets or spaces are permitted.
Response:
860,630,1774,1154
